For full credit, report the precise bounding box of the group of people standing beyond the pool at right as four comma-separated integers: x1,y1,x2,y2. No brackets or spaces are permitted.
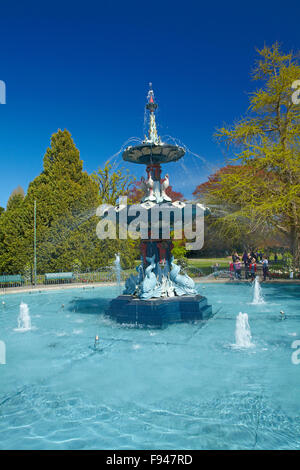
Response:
229,250,271,281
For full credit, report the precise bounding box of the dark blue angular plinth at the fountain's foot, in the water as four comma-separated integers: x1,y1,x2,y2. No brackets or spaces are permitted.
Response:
105,295,212,328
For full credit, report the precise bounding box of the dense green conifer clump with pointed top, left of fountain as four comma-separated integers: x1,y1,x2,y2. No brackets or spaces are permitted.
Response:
0,130,100,273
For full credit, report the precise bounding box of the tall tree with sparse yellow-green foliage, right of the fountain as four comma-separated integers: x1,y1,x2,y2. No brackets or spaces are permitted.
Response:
199,43,300,264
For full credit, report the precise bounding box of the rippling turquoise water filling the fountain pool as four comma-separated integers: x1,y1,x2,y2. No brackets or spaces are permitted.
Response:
0,284,300,449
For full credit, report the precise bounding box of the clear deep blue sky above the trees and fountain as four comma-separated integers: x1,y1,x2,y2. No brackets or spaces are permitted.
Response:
0,0,300,206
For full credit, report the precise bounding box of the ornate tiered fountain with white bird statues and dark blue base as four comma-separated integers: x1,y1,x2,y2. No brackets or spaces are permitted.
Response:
106,84,212,327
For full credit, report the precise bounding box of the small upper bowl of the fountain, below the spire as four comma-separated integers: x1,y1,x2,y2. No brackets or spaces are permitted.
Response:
123,143,185,165
